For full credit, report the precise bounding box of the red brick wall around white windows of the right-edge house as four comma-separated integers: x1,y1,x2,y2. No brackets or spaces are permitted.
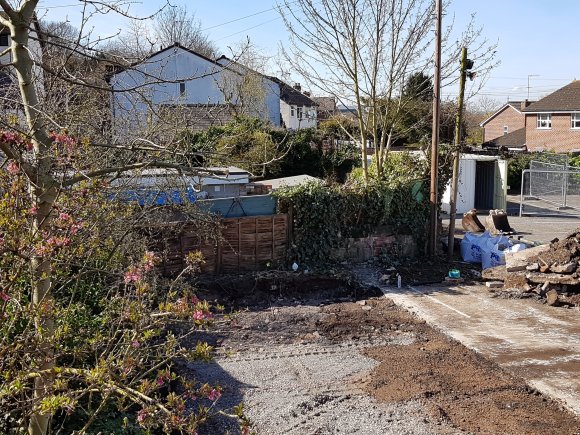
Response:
526,113,580,152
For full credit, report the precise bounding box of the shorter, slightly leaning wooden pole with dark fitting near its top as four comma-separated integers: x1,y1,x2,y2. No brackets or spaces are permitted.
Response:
447,47,473,260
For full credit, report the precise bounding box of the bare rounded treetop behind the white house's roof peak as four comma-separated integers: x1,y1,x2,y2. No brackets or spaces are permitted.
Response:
155,6,217,58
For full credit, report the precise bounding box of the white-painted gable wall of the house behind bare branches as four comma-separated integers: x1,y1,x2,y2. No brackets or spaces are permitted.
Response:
109,43,280,134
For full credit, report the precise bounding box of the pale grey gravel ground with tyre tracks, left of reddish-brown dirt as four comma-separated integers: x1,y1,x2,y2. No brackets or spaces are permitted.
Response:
190,301,461,434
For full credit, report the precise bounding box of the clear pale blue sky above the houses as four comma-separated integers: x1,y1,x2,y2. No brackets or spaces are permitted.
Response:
39,0,580,104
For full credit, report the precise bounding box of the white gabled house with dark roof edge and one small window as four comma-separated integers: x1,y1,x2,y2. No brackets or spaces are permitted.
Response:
109,43,280,135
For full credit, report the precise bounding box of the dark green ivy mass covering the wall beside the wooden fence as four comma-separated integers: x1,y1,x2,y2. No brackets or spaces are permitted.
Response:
276,181,429,264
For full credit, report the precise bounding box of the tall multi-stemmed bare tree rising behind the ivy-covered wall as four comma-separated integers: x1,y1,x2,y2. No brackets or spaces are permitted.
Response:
279,0,496,181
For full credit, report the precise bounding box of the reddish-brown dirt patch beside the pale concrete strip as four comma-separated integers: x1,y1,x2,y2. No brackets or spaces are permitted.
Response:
364,316,580,435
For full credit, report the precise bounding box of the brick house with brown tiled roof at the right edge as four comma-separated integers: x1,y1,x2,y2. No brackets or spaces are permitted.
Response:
522,80,580,152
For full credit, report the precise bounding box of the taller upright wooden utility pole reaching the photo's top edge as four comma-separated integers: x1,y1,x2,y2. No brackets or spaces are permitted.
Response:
428,0,442,257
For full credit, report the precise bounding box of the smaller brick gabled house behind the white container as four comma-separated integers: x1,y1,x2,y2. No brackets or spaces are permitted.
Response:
479,100,530,147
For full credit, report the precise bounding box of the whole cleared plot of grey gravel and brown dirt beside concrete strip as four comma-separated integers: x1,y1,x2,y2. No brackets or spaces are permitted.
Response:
196,278,580,435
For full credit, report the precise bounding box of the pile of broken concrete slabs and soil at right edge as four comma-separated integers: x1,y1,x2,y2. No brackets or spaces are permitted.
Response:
482,228,580,306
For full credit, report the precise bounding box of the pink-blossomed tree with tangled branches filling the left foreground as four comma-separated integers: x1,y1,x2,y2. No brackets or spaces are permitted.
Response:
0,0,248,435
